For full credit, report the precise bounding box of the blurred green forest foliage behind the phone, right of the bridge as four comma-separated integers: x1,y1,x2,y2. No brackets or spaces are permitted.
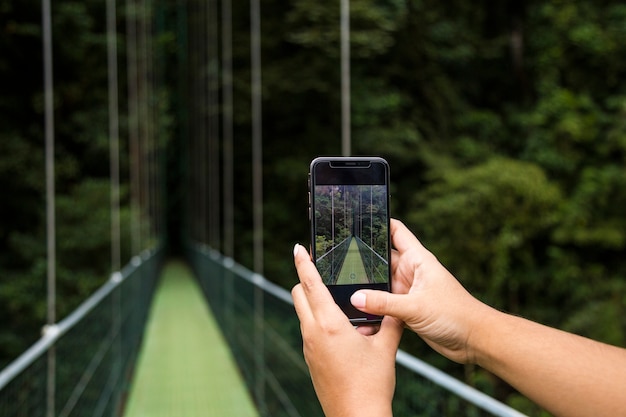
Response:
244,0,626,413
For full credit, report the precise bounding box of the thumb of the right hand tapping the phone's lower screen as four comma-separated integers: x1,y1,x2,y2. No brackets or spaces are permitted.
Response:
350,290,415,321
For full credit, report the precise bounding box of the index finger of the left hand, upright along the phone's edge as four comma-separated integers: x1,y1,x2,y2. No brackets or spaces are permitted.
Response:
294,245,343,317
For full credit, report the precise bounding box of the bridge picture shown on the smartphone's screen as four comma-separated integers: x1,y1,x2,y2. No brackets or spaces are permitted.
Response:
315,185,389,285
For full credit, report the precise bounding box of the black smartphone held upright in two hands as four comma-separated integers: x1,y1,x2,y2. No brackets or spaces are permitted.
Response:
309,157,391,325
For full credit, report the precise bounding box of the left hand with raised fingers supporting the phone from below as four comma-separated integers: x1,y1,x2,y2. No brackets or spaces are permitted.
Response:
291,245,403,416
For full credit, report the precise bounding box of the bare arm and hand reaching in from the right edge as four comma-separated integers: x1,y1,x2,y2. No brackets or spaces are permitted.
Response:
352,220,626,416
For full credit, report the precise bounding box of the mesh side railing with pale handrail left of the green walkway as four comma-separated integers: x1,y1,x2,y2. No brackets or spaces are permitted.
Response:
0,251,162,417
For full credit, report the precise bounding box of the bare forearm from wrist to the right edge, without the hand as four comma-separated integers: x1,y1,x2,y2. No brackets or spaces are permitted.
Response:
470,310,626,416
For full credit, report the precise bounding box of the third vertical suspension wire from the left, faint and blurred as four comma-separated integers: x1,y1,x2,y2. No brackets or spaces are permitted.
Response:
126,0,142,255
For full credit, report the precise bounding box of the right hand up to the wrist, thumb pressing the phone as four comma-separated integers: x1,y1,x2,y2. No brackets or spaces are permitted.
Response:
351,219,493,363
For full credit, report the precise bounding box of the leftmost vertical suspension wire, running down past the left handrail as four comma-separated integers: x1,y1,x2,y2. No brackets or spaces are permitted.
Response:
41,0,56,417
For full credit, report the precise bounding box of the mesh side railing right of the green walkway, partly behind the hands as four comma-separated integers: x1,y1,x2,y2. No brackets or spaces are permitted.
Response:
188,246,522,417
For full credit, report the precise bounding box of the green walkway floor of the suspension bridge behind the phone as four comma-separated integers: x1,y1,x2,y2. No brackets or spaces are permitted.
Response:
125,262,258,417
